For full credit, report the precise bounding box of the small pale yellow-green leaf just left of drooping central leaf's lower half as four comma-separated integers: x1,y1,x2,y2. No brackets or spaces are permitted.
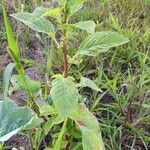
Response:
39,105,57,116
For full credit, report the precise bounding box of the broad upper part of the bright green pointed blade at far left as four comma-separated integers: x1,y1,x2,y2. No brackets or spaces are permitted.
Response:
2,1,21,64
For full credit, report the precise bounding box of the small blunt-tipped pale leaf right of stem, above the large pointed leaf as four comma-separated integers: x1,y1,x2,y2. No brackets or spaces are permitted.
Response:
69,20,96,34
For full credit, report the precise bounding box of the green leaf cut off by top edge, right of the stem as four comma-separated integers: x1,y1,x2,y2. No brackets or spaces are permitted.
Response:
65,0,86,16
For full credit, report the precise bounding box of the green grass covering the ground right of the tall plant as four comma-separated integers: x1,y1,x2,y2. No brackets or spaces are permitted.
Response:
0,0,150,150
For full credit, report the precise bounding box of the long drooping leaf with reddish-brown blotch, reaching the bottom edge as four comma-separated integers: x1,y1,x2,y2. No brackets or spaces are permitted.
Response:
74,104,104,150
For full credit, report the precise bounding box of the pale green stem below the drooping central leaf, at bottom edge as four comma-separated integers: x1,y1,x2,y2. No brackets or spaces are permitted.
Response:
54,119,67,150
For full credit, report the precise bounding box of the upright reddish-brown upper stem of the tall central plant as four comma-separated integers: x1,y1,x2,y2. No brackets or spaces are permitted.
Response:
62,13,68,78
